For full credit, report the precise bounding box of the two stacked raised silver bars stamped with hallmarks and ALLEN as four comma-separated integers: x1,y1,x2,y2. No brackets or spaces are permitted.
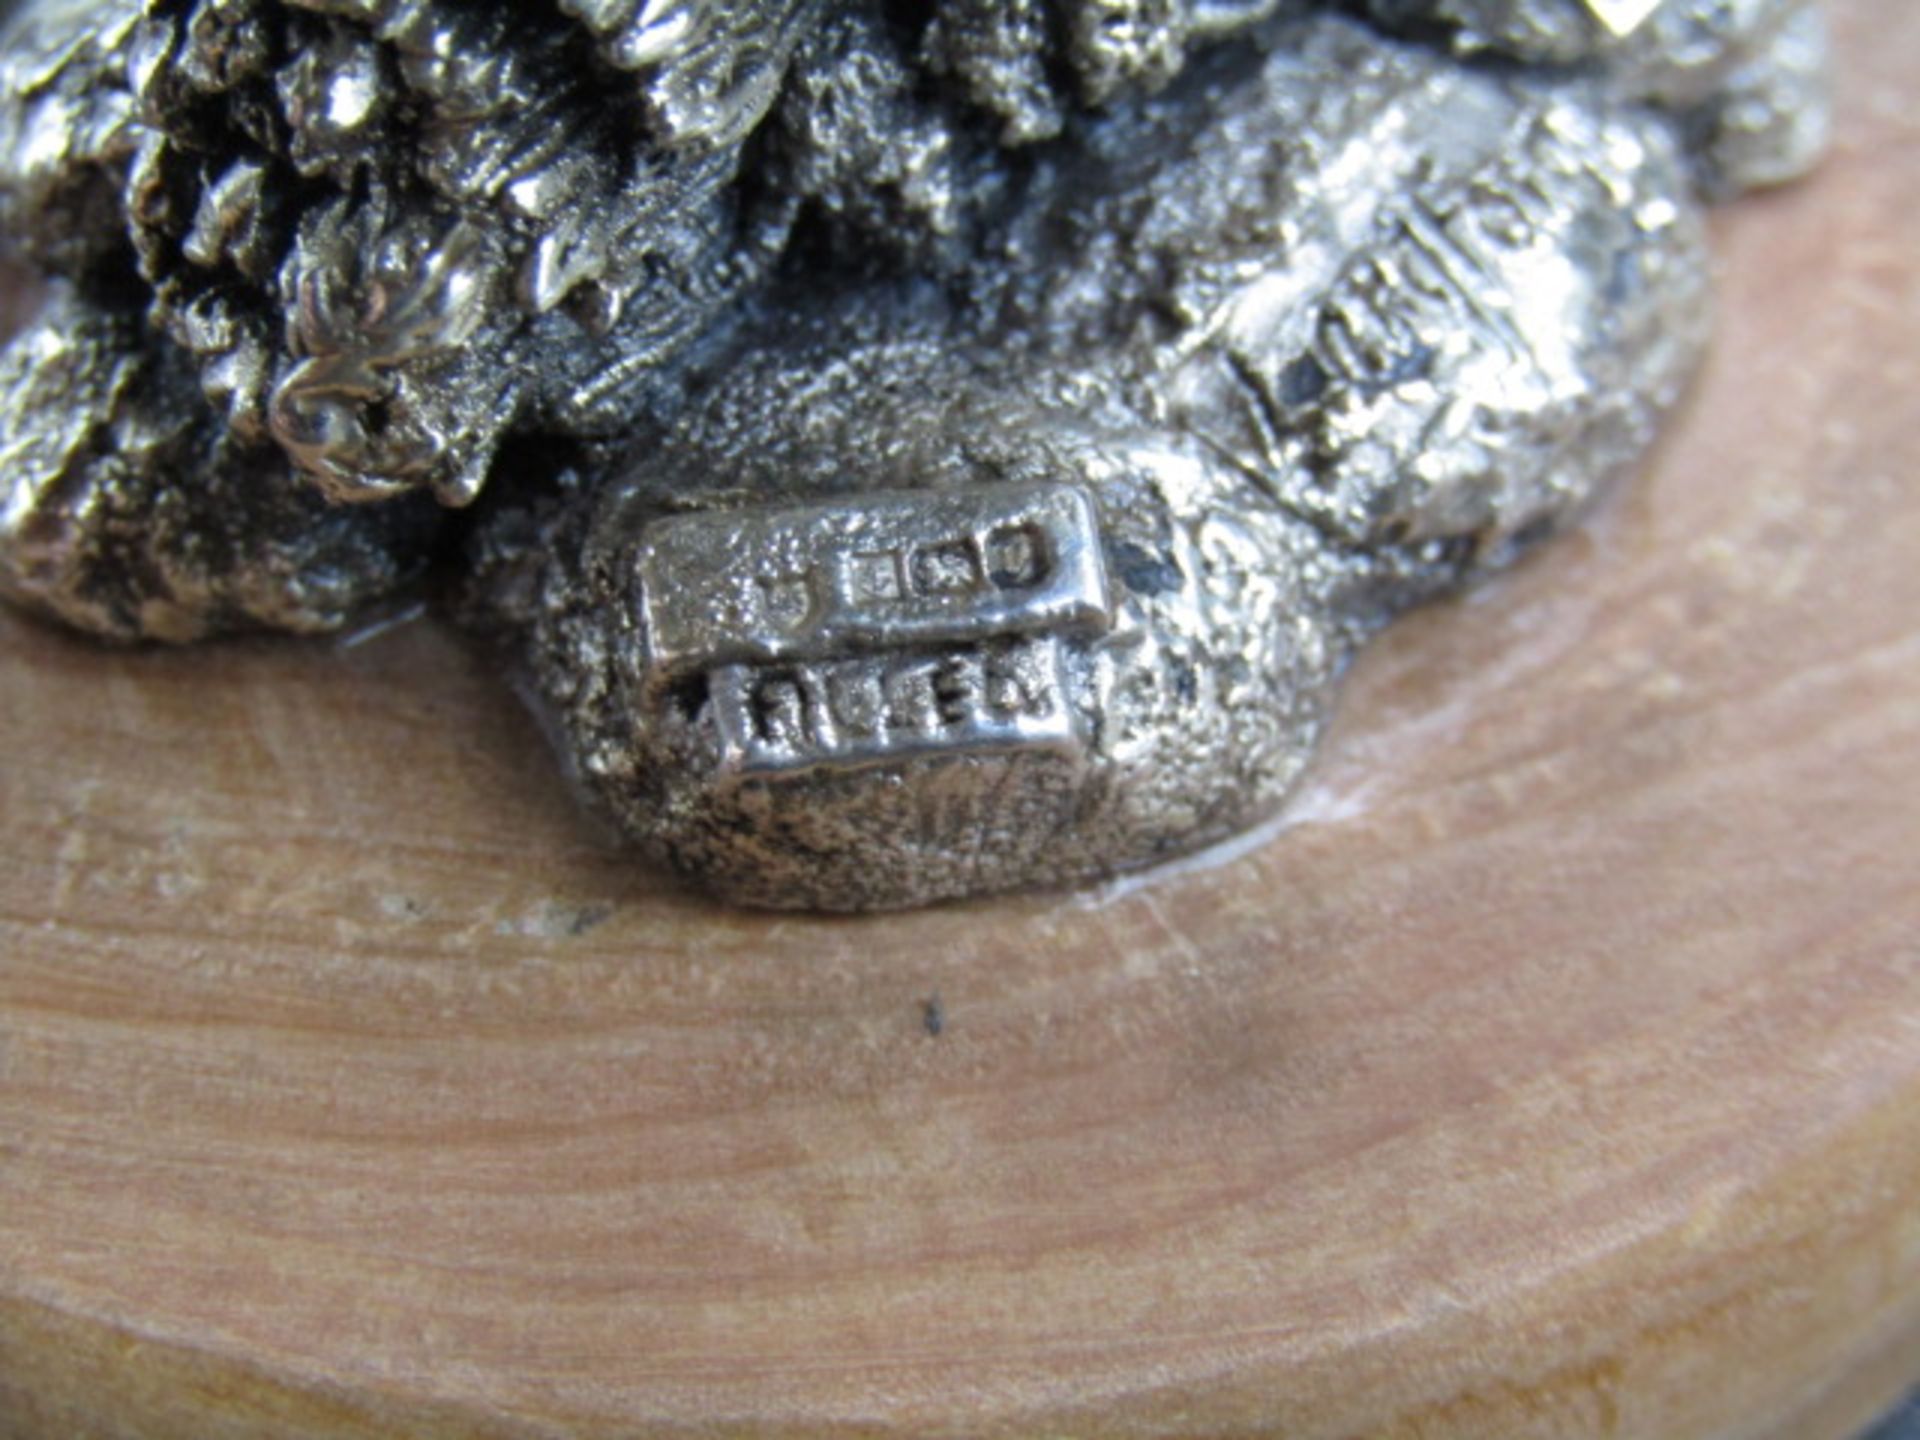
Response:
636,484,1112,776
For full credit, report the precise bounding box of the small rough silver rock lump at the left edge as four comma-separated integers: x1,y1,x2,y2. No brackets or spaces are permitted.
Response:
0,288,440,641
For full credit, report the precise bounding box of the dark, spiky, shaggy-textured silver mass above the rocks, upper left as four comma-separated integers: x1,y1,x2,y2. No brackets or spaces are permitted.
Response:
0,0,1336,529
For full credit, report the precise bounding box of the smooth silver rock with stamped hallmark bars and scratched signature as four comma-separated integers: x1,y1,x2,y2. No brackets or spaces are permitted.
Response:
468,19,1728,908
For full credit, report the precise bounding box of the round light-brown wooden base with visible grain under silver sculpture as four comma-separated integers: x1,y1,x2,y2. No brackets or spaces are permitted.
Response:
0,0,1920,1440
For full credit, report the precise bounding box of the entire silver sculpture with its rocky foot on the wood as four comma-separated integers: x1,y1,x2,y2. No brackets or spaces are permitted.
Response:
0,0,1826,908
